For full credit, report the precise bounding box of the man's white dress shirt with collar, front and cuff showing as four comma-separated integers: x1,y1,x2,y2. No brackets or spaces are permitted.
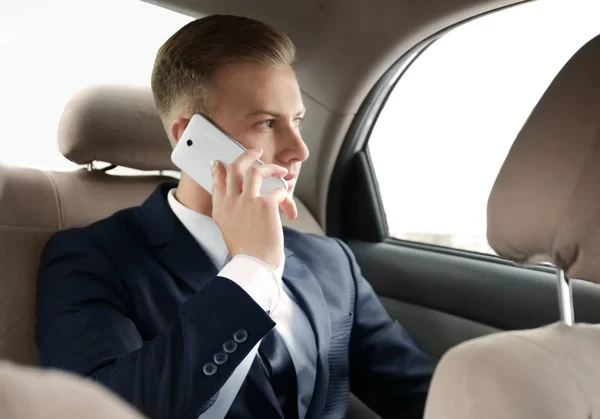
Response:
168,189,317,419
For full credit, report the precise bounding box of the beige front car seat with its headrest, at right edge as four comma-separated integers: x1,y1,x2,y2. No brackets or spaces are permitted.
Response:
425,36,600,419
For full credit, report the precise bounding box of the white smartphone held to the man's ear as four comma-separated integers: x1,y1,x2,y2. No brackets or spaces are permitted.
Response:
171,114,287,195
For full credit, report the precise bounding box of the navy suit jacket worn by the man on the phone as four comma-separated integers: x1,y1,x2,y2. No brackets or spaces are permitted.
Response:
35,184,432,419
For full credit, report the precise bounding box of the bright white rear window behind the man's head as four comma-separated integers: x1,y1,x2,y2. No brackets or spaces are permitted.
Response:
0,0,191,170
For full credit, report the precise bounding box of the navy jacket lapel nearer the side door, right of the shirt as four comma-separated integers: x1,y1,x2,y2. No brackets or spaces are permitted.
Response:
283,248,331,418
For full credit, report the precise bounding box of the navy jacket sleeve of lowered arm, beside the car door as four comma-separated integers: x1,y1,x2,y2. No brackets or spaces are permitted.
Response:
340,241,433,419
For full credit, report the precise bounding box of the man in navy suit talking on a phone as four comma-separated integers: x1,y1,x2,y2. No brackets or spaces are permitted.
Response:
36,16,432,419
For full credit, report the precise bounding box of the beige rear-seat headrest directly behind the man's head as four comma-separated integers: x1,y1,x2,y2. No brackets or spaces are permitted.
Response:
58,85,176,170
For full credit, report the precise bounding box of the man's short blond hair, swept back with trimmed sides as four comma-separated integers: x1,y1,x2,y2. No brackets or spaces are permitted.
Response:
151,15,296,143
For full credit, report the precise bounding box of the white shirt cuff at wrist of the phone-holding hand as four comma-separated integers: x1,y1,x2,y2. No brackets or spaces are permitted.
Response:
219,255,283,314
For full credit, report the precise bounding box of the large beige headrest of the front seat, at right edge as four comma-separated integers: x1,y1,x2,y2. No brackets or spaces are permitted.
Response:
487,36,600,283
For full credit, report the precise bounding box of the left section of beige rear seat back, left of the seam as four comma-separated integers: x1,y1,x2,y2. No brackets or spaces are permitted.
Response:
0,166,58,363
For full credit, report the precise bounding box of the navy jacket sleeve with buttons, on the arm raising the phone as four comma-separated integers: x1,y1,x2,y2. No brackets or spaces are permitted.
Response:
35,230,275,419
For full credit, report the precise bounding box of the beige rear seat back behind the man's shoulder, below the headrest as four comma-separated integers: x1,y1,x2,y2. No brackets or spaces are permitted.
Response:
0,166,167,364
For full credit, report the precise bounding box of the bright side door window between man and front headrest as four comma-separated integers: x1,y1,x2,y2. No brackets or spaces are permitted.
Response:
368,0,600,254
